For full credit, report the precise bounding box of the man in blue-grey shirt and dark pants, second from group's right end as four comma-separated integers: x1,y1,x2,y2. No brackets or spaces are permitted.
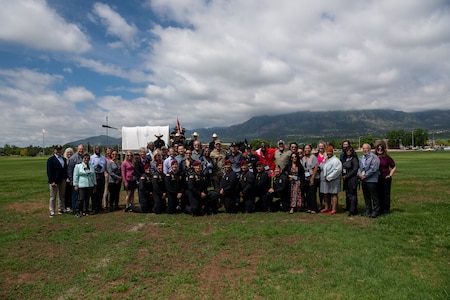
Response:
358,144,380,218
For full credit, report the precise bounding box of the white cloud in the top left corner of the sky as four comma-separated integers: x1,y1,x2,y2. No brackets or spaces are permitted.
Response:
0,0,91,53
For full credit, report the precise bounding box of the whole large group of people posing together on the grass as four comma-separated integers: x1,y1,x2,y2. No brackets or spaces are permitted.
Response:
47,133,396,218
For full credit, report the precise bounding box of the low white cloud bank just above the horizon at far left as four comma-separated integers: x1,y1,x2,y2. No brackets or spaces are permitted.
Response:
0,69,104,146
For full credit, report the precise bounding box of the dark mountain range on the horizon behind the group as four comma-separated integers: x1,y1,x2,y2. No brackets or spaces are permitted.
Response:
68,110,450,146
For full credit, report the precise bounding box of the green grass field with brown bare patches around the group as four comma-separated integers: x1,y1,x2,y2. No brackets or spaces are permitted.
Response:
0,152,450,299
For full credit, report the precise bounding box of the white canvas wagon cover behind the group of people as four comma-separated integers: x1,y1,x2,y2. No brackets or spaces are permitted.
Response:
122,125,169,151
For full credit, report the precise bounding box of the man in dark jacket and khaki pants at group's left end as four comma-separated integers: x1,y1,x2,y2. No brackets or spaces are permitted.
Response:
47,145,67,218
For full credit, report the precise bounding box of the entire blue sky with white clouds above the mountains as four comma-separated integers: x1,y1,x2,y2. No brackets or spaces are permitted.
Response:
0,0,450,146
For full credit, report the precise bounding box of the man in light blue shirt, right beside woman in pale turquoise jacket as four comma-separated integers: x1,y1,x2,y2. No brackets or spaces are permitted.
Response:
89,145,106,214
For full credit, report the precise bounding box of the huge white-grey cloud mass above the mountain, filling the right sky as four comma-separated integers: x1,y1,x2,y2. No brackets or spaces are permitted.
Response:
138,0,450,126
